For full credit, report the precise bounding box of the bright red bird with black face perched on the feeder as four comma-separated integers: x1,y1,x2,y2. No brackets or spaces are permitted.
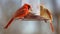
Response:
4,4,31,29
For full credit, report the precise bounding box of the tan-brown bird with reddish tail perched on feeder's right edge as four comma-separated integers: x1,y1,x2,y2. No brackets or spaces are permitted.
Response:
40,5,54,32
